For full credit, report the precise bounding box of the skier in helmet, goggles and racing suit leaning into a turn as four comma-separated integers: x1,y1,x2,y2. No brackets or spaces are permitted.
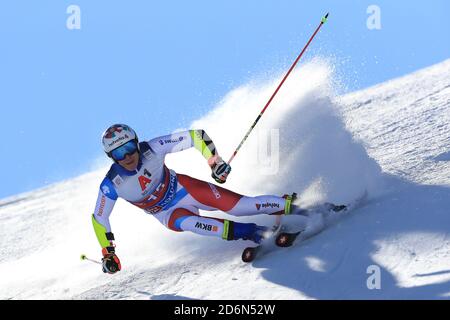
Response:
92,124,338,274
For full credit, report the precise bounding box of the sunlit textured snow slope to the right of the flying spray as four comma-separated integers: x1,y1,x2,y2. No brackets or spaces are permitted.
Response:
341,60,450,185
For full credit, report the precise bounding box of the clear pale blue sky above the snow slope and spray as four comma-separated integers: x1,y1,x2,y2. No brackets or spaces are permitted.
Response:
0,0,450,198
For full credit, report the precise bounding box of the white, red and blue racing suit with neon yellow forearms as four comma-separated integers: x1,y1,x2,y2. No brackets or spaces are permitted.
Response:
92,130,290,248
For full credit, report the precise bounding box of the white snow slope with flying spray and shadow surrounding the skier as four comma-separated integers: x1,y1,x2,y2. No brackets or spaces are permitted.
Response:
0,59,450,299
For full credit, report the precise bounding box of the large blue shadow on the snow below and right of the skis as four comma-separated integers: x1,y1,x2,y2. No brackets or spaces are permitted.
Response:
253,182,450,299
